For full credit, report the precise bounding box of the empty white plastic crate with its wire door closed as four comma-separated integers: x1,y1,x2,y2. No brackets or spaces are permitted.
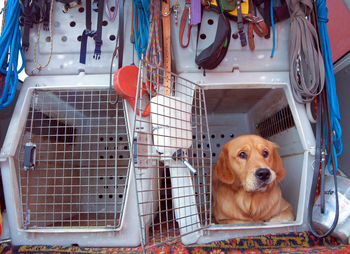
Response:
1,75,150,246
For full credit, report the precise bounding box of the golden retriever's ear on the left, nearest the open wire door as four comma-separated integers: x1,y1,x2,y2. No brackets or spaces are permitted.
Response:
215,145,235,184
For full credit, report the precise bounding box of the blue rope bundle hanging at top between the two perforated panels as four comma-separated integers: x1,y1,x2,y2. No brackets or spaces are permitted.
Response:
133,0,150,59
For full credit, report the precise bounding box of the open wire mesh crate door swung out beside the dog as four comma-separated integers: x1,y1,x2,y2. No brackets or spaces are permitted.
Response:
131,61,212,247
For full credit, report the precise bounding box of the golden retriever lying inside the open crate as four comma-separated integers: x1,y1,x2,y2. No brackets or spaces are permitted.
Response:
212,135,294,224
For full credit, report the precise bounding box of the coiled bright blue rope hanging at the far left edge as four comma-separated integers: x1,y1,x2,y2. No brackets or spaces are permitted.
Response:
0,0,25,110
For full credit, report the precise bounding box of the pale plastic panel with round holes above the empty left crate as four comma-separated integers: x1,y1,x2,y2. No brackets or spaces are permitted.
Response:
25,1,137,75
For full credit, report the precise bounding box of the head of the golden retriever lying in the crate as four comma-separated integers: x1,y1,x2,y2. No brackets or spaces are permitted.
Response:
215,135,286,192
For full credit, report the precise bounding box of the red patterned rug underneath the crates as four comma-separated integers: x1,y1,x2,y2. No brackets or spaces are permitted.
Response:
0,232,350,254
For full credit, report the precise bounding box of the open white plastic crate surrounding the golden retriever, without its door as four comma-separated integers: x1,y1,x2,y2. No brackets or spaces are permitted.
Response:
184,72,315,243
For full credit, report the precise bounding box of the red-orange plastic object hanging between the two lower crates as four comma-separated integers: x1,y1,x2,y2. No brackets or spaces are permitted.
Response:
113,65,151,117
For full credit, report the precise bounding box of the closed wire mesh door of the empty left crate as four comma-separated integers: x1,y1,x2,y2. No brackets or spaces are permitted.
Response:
17,89,130,230
